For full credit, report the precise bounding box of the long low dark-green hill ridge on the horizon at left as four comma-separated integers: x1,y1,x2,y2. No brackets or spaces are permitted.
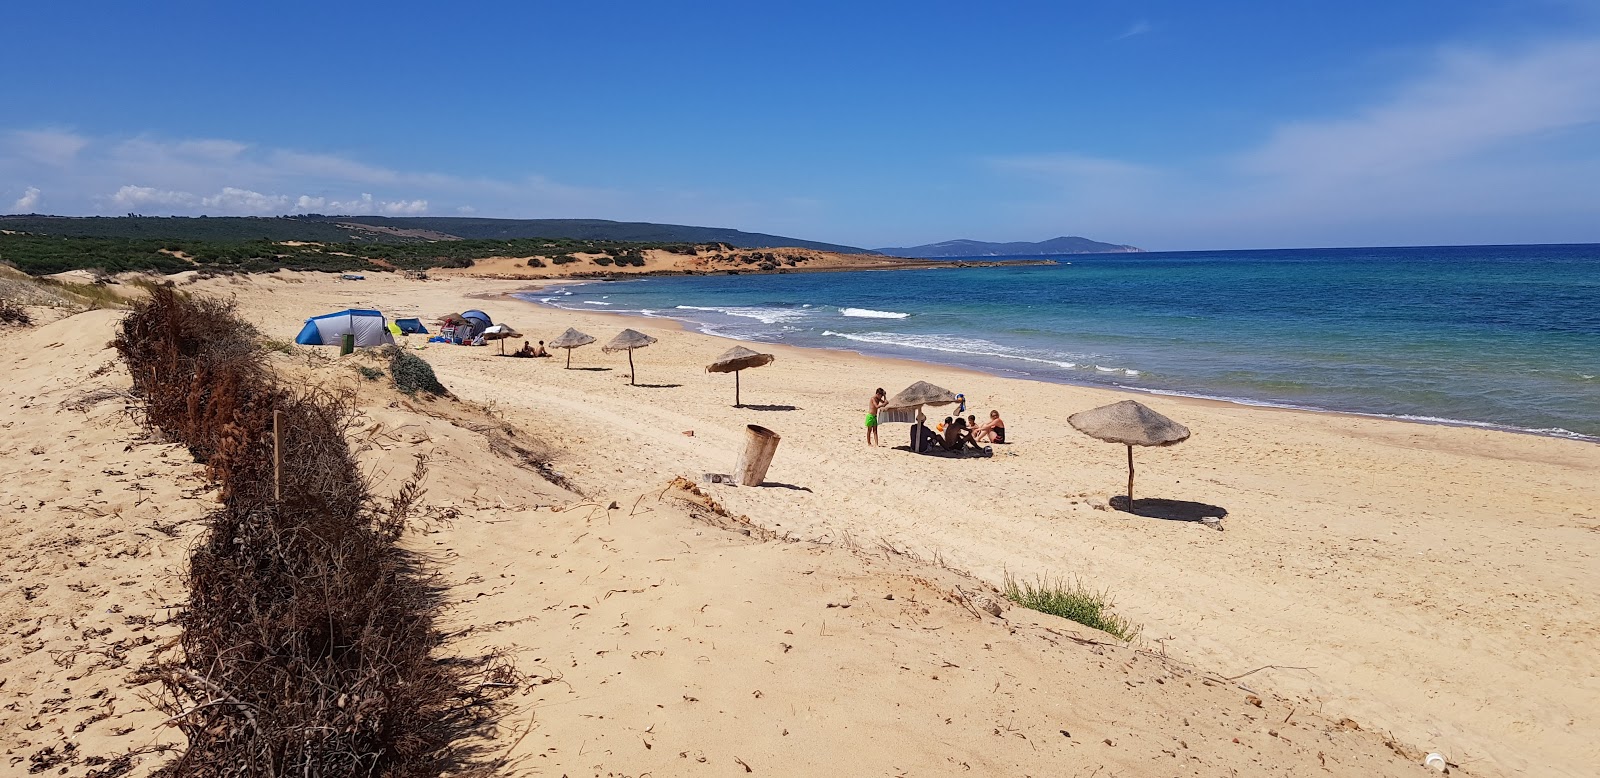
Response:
0,215,866,255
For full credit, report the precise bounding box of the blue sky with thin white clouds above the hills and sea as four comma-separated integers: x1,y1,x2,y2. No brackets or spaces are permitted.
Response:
0,0,1600,250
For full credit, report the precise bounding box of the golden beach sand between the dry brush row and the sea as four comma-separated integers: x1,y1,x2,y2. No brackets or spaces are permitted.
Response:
3,272,1600,776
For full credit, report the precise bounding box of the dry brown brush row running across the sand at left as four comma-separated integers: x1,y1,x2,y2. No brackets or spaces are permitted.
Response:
115,287,514,776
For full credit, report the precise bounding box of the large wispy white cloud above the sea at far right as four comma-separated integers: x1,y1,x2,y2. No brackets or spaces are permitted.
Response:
987,40,1600,248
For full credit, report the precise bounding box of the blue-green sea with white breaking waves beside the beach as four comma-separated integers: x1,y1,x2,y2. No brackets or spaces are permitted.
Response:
522,245,1600,442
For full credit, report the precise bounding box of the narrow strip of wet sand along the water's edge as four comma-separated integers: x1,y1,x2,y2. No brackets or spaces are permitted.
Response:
508,284,1600,445
